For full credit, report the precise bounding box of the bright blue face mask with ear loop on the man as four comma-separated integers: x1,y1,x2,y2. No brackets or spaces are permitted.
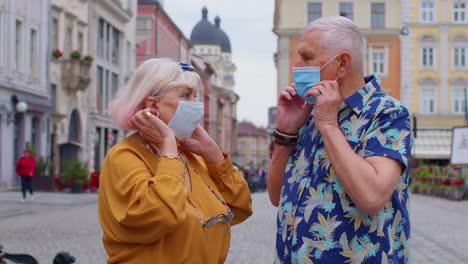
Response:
293,53,339,104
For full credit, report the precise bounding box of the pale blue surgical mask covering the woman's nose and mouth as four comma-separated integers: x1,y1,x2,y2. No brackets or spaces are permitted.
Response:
167,101,204,139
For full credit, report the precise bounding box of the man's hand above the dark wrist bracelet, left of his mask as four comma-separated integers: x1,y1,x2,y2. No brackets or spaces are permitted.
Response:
276,84,312,134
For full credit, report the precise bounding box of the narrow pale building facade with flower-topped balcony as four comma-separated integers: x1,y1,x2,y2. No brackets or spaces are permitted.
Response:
47,0,94,177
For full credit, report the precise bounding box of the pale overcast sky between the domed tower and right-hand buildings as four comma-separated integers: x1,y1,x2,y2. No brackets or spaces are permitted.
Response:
164,0,276,127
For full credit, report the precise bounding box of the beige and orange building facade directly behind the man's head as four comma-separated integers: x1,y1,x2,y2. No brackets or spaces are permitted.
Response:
273,0,401,99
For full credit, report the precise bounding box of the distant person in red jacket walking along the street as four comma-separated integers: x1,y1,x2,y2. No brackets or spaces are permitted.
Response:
16,148,36,202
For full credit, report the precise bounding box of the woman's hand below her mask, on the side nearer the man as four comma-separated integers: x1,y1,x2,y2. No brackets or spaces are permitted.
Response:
179,125,224,165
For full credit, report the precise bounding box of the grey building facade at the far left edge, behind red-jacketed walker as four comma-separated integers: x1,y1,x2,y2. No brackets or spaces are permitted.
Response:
0,0,51,188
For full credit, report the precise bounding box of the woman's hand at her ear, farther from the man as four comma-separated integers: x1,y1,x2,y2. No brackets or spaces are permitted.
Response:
131,108,177,155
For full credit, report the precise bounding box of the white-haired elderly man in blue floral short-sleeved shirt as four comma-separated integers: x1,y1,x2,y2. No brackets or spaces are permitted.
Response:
268,17,411,263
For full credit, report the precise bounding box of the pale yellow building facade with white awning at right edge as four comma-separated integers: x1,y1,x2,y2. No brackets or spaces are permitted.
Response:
401,0,468,162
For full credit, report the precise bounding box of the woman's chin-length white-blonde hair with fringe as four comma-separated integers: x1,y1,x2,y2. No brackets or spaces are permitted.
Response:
110,58,201,130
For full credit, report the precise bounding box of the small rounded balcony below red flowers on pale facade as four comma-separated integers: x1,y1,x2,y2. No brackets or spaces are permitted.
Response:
62,59,92,93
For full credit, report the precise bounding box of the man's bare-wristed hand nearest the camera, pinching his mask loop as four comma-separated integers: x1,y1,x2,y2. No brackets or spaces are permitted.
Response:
306,81,343,132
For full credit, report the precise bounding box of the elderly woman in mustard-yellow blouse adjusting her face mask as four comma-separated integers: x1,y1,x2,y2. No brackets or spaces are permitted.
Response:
98,59,252,263
